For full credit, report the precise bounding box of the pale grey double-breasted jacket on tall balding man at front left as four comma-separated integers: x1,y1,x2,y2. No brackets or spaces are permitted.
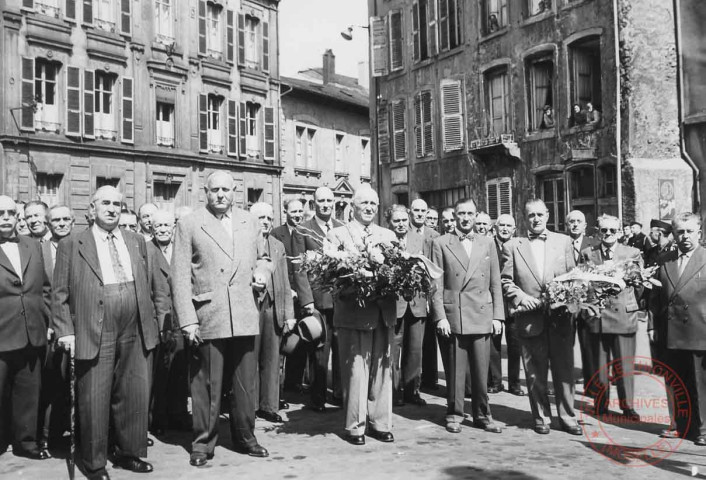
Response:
171,207,271,340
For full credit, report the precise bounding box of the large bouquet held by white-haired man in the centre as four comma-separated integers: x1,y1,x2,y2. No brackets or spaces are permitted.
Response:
292,230,434,306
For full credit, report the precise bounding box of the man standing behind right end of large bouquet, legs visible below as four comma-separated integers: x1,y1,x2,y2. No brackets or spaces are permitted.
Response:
386,205,428,406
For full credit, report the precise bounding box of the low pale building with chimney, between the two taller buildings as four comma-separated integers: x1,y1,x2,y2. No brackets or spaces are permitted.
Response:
281,50,371,219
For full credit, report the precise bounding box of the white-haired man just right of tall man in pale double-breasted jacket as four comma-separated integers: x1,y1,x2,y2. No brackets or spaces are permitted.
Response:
250,202,296,422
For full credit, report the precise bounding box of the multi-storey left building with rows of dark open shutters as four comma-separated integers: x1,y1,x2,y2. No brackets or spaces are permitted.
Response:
0,0,281,223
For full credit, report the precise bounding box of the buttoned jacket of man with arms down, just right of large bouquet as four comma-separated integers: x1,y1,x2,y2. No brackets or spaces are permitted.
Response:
431,233,505,335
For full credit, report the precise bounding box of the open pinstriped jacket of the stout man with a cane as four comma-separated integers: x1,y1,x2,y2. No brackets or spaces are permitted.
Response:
52,229,159,360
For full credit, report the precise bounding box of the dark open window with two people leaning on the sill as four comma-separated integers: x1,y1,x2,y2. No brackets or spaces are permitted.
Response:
569,36,601,113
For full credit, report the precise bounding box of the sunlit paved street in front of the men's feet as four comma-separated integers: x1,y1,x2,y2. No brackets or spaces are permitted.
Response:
0,326,706,480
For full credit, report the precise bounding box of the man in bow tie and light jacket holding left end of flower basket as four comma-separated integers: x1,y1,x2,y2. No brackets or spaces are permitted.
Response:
501,199,582,435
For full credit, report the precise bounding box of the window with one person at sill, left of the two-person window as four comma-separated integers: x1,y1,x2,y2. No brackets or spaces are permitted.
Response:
525,56,554,131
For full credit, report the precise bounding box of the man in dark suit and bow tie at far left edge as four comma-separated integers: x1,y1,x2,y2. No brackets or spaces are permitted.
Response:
0,195,51,460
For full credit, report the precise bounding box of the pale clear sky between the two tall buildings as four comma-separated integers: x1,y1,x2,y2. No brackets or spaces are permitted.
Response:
279,0,368,77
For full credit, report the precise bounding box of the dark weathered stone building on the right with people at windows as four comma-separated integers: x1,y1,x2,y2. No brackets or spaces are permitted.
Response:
368,0,697,231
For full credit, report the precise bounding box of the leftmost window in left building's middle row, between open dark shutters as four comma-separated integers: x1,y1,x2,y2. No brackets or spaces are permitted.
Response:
34,58,61,133
